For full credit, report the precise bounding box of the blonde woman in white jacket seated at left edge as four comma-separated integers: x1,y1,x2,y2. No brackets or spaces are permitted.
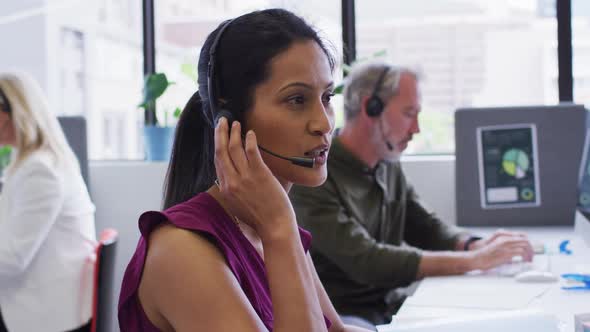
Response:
0,73,96,332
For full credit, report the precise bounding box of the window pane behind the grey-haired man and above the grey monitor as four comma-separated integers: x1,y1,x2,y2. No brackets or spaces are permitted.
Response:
356,0,560,154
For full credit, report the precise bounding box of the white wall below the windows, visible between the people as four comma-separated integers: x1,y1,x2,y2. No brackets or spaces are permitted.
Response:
89,156,456,327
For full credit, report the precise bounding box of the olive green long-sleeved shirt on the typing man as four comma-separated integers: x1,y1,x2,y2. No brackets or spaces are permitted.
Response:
290,137,462,320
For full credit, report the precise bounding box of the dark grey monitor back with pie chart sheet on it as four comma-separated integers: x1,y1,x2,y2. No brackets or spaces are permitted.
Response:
455,104,587,227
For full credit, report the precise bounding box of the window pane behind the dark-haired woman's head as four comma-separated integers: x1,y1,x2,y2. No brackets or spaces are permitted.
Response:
155,0,342,132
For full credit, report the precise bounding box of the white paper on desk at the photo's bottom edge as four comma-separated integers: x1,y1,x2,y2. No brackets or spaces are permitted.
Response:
377,310,560,332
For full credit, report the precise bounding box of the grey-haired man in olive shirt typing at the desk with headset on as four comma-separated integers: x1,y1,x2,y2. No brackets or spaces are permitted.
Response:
290,63,533,324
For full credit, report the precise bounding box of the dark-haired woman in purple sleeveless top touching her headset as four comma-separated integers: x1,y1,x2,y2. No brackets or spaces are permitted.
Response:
119,9,374,331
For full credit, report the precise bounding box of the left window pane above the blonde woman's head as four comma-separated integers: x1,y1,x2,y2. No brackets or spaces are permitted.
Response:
0,0,143,159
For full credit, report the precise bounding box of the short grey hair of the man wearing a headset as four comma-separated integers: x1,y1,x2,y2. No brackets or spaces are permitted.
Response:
343,62,420,120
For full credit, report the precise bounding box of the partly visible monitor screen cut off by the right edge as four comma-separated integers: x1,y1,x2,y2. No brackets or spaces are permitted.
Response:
575,124,590,246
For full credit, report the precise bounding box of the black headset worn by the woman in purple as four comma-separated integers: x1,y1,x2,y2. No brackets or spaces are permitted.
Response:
207,19,315,168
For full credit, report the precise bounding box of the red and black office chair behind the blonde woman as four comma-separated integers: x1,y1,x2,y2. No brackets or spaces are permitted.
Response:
90,228,118,332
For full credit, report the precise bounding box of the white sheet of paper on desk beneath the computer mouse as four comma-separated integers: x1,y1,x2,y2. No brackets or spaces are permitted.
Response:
404,275,553,310
